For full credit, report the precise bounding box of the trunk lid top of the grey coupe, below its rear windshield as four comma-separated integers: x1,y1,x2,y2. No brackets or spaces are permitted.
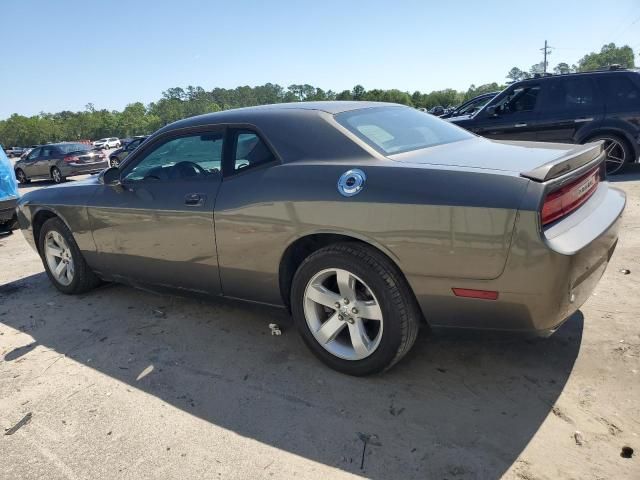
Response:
389,137,584,175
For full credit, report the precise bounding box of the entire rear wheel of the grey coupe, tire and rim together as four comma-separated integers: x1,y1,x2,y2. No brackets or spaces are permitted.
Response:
291,243,420,376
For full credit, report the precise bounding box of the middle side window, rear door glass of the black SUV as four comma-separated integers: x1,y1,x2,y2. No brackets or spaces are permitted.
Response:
545,76,598,113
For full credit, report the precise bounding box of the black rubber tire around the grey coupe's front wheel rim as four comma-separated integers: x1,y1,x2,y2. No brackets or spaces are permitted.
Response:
38,217,100,295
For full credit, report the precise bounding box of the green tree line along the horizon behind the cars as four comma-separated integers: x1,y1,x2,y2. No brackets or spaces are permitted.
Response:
0,44,635,146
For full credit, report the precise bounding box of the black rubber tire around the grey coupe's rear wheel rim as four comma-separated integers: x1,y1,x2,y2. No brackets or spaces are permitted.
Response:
291,243,421,376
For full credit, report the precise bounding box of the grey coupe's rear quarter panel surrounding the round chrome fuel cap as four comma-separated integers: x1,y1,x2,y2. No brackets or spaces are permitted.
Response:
215,160,528,304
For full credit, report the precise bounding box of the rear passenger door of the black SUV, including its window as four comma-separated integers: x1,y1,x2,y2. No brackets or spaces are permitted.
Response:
537,75,604,143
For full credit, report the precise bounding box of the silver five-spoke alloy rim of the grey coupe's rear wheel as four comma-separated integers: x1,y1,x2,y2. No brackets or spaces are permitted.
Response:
304,268,384,360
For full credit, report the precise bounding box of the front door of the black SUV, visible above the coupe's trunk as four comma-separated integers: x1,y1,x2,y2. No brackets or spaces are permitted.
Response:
468,82,540,140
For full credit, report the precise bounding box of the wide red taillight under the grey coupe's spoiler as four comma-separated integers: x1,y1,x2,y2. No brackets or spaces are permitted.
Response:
540,169,600,225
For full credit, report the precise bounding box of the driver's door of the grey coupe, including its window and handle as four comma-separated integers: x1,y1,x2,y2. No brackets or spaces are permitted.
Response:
88,128,224,294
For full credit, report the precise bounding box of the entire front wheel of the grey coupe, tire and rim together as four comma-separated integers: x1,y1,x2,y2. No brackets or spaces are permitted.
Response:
38,217,100,294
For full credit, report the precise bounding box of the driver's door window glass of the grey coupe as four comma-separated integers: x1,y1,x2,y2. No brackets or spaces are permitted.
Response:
124,132,224,181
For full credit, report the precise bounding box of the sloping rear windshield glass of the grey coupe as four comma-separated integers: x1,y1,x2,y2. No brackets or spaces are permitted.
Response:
335,107,473,155
